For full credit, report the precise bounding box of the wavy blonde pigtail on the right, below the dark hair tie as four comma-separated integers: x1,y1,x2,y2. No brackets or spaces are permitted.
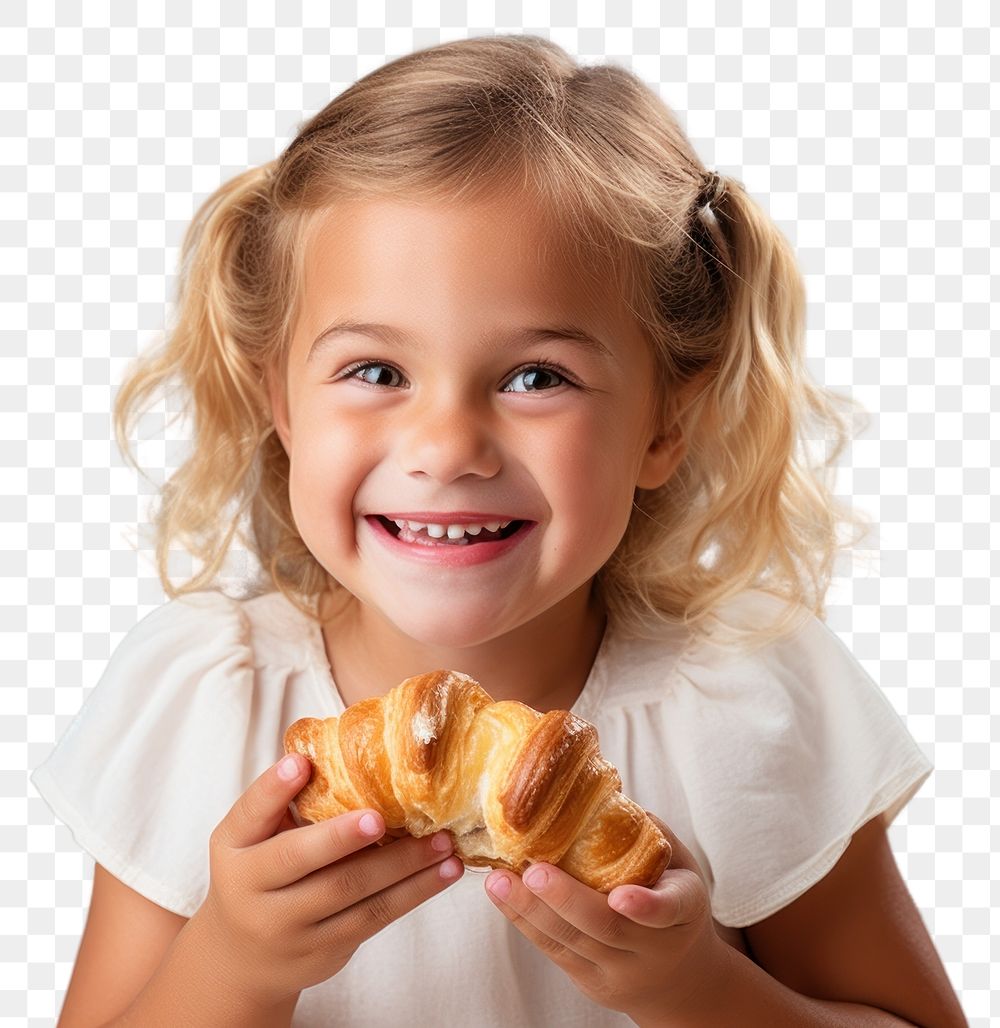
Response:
601,179,867,645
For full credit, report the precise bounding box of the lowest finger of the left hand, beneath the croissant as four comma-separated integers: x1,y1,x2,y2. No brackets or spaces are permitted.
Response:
317,840,465,949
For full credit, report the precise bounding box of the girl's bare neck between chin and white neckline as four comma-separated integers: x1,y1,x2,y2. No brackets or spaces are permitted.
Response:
320,583,605,713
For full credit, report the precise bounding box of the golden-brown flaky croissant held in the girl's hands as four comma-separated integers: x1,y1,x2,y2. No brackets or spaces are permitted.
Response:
285,671,670,892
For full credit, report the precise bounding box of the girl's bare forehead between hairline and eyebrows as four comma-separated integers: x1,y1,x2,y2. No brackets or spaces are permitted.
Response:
291,192,627,331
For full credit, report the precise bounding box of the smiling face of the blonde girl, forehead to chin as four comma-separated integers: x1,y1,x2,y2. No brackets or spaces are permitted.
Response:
271,189,681,648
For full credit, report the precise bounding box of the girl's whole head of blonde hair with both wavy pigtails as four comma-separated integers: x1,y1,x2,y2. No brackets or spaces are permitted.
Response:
114,35,864,638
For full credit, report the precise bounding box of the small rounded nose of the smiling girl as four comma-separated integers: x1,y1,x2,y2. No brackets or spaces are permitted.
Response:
397,396,503,483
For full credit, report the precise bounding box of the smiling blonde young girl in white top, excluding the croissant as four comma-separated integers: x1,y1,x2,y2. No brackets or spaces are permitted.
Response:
33,36,964,1028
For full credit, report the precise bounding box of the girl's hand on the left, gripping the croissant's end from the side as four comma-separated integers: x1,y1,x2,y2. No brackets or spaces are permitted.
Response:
190,755,464,1007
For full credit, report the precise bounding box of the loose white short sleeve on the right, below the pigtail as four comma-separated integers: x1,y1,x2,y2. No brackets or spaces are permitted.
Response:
674,596,933,927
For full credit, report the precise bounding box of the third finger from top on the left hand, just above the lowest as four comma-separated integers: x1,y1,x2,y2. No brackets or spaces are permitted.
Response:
287,832,464,922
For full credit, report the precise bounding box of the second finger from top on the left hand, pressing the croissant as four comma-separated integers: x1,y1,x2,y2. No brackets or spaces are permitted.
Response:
247,809,390,890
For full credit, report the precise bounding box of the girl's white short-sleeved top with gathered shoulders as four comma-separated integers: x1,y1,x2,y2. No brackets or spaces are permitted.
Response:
32,590,933,1028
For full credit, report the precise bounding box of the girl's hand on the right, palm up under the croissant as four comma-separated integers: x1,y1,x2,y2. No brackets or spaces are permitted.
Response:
486,815,729,1025
